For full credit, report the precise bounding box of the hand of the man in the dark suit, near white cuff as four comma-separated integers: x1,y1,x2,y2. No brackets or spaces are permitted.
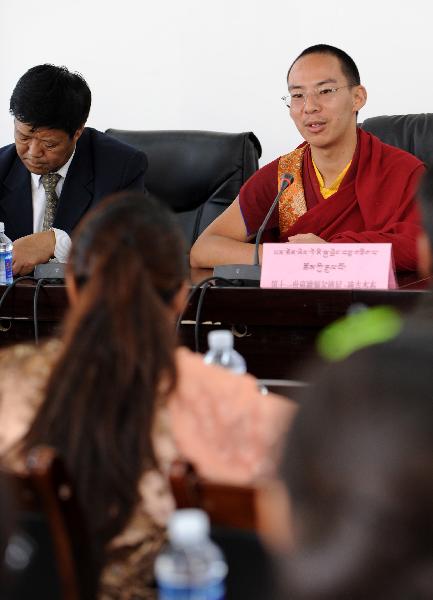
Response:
12,230,56,275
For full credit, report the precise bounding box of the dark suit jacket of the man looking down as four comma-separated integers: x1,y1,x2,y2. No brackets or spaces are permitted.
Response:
0,127,147,240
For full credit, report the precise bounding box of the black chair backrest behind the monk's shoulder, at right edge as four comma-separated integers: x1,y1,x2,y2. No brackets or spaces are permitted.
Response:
360,113,433,166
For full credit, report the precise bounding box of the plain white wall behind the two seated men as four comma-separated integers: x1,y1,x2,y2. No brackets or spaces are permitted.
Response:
0,0,433,164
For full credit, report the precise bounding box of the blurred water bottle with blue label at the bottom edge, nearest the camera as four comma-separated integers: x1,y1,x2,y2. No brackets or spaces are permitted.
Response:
155,509,227,600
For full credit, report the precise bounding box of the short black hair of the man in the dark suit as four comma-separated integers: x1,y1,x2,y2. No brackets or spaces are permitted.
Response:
9,64,92,138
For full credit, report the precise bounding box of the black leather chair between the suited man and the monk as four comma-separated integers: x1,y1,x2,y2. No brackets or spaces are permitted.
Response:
106,129,261,250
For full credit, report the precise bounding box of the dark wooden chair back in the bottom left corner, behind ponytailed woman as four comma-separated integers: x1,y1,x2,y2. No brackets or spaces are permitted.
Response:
0,446,97,600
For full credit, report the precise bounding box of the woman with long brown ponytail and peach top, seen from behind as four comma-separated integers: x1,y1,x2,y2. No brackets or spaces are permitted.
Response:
0,192,294,599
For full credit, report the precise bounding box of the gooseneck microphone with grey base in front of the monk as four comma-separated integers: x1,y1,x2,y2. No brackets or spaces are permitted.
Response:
213,173,294,286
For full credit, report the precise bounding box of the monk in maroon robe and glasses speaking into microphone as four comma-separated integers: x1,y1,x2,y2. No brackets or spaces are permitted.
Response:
191,44,424,270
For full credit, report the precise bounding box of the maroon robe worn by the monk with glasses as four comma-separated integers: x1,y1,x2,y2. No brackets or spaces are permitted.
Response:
239,129,424,270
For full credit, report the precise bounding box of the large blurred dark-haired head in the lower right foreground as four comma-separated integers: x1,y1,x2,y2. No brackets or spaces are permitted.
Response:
264,328,433,600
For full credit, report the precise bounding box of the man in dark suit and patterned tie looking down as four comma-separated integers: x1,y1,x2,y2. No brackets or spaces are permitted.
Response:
0,64,147,274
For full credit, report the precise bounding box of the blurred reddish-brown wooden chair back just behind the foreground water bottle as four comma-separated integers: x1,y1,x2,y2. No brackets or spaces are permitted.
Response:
170,461,259,531
